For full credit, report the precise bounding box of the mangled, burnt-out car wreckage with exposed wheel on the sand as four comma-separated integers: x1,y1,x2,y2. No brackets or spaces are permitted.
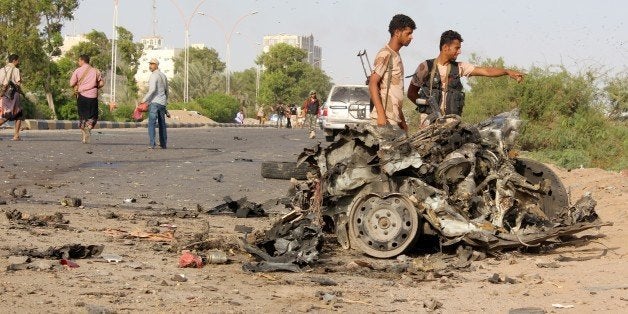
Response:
274,110,609,258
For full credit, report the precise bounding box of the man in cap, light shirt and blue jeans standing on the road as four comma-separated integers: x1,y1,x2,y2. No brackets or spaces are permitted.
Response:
142,58,168,149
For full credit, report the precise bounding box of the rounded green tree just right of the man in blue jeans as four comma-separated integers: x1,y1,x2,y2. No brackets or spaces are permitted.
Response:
169,48,225,101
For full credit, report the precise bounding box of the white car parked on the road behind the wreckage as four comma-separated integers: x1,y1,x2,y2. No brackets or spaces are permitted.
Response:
321,85,371,142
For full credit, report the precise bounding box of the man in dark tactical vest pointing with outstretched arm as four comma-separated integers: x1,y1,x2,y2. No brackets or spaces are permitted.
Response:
408,30,523,128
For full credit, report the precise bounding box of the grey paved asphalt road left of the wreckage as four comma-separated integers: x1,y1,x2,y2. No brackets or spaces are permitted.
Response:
0,128,323,209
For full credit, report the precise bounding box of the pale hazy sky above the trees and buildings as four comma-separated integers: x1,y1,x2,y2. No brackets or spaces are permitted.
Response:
64,0,628,85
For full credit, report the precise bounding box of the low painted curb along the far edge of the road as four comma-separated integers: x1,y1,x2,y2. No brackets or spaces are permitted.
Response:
22,119,274,130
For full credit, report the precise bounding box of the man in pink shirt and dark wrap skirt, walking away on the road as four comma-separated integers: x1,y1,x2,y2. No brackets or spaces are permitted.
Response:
70,55,105,144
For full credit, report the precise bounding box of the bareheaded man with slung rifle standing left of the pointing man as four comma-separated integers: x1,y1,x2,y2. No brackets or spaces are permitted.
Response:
369,14,416,134
